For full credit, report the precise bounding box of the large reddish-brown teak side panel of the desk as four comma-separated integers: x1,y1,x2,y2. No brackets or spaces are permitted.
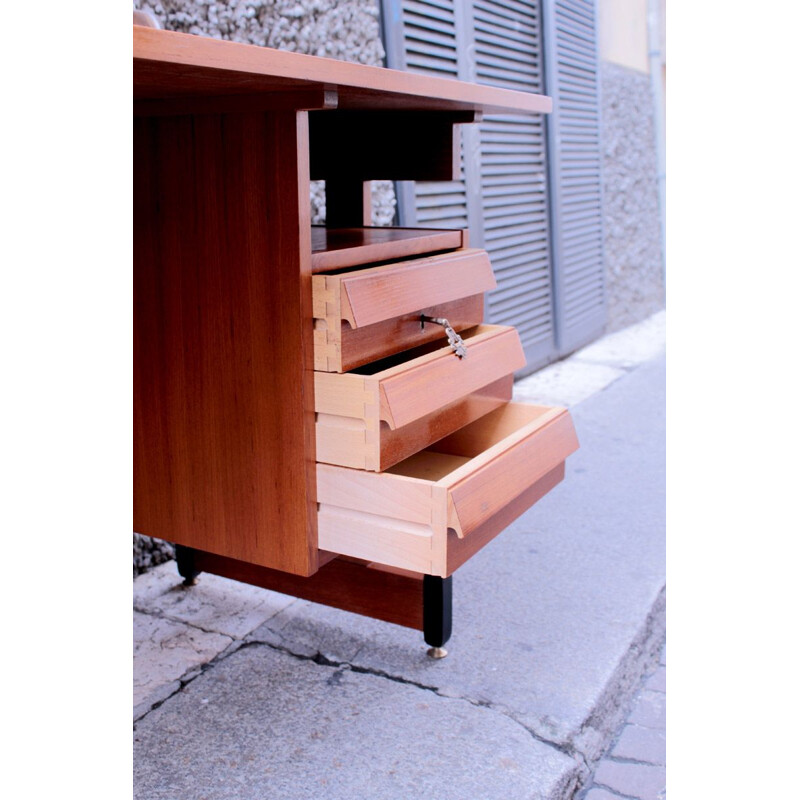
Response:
134,111,317,575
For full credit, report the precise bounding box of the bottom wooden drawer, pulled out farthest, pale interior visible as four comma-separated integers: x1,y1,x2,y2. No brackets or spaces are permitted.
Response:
317,403,578,577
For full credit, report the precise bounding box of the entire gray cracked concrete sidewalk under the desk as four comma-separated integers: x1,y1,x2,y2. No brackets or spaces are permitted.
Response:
134,312,665,800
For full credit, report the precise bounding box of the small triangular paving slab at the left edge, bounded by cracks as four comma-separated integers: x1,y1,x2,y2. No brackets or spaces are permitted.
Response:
133,611,232,718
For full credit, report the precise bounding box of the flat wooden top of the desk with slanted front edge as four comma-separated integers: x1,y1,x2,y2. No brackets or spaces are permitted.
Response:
133,25,552,114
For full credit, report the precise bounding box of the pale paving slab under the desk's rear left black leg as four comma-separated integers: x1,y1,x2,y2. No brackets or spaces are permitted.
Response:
133,561,296,638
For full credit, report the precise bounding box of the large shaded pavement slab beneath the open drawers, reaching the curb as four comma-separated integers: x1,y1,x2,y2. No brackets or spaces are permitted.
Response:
252,357,665,764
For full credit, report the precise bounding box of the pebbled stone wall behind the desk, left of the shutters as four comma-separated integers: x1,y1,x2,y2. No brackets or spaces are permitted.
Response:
133,0,395,575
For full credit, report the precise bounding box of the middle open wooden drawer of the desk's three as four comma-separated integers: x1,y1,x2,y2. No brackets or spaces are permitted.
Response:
314,325,525,471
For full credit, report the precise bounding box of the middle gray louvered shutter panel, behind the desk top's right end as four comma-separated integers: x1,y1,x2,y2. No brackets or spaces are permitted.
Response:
472,0,555,372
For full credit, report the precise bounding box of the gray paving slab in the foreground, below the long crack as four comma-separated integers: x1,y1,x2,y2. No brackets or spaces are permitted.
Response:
134,645,577,800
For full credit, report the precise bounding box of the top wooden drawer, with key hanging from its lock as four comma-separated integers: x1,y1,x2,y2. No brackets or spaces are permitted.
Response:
311,249,496,372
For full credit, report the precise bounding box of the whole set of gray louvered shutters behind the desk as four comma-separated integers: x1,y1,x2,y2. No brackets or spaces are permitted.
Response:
382,0,606,371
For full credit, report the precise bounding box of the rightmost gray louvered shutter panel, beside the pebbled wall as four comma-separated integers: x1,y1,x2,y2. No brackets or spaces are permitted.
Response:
544,0,606,355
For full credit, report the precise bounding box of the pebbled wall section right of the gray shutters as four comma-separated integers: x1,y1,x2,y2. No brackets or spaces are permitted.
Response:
601,63,665,332
